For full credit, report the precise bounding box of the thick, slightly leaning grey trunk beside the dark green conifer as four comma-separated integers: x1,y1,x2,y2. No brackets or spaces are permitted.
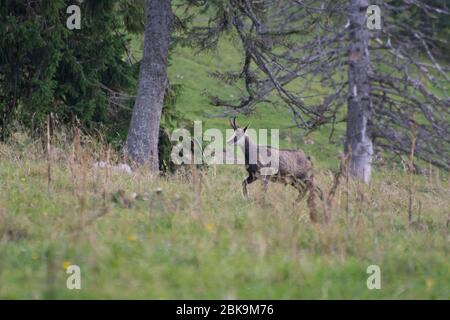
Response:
125,0,172,171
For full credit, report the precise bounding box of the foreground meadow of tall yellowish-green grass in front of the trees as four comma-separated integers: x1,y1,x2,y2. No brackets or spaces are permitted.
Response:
0,141,450,299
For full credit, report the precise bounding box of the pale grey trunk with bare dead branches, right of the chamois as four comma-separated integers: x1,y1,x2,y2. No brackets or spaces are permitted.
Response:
345,0,373,182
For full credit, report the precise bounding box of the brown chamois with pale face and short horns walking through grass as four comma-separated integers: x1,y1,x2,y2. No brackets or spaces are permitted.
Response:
228,117,323,221
